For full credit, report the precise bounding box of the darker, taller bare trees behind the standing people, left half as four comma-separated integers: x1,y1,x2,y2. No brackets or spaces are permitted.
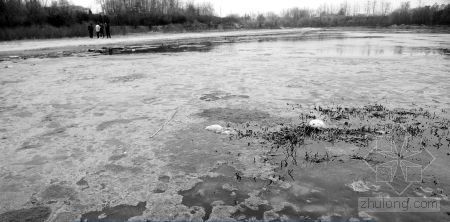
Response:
0,0,220,28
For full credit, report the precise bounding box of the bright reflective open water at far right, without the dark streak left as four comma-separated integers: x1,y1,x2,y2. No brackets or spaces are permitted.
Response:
221,31,450,57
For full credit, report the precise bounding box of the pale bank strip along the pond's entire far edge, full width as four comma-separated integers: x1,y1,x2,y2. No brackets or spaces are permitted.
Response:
0,26,450,61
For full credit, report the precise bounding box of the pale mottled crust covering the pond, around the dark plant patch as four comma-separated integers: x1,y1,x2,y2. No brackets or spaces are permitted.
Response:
0,29,450,221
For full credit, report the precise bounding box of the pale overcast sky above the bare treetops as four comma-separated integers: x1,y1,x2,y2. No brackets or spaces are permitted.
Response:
71,0,450,16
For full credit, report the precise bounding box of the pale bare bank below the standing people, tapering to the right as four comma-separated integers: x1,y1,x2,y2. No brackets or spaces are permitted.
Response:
0,28,314,57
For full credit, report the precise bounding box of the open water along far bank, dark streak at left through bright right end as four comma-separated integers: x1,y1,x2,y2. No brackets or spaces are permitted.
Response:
105,30,450,57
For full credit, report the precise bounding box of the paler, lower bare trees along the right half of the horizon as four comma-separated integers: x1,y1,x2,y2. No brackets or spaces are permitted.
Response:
237,0,450,28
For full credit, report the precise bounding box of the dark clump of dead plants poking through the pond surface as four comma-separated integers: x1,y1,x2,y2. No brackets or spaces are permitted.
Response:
232,104,450,166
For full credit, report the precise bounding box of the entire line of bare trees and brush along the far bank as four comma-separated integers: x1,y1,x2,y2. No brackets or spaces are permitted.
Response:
0,0,450,40
